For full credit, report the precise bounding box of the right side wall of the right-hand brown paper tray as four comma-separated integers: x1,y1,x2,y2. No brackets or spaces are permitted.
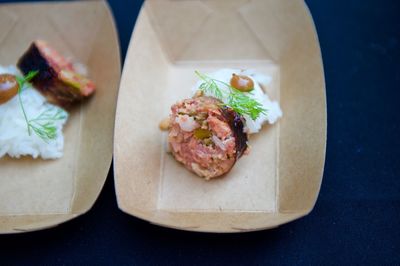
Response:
279,1,327,212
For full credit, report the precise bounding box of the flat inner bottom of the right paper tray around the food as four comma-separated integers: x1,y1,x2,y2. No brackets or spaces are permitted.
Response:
155,61,279,212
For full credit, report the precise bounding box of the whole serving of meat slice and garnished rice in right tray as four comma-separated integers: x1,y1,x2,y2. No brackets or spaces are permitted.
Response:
160,69,282,180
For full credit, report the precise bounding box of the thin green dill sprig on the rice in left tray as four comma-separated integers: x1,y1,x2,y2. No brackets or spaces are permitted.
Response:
16,71,67,142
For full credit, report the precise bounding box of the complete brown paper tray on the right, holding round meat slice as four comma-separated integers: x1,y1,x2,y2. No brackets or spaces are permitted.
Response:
114,0,326,232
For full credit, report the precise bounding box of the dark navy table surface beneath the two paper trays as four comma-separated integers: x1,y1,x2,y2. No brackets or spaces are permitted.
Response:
0,0,400,265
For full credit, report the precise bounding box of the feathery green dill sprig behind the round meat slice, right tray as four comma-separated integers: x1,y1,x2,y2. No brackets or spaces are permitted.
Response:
195,70,267,120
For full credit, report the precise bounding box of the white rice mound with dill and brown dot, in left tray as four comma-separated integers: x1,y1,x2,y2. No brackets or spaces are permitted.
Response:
0,66,68,159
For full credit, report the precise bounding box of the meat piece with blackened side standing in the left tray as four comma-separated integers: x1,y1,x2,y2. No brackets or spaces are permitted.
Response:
17,40,95,108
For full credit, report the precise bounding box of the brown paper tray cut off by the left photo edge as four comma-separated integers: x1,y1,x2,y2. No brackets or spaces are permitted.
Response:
0,1,120,233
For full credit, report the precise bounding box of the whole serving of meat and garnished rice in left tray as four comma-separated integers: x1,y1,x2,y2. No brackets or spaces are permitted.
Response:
0,41,95,159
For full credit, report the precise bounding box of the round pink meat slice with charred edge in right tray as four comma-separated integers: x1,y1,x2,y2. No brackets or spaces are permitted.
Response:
168,96,247,180
